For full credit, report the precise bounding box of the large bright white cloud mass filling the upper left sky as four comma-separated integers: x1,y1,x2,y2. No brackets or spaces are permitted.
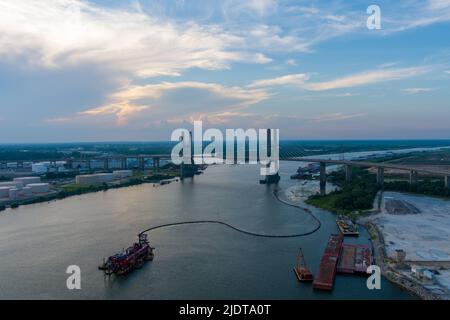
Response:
0,0,270,77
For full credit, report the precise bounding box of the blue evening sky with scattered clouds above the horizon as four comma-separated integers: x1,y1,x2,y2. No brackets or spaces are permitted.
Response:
0,0,450,143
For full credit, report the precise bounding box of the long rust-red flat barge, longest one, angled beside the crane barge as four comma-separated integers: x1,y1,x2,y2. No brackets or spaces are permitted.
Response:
313,234,344,291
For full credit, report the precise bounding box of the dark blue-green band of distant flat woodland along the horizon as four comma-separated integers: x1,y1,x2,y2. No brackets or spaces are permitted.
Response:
0,140,450,161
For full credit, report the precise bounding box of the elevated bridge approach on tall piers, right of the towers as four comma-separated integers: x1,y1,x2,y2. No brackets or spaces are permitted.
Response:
280,158,450,194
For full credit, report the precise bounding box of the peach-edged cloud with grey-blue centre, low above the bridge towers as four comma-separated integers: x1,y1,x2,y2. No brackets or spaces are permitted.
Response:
48,82,270,126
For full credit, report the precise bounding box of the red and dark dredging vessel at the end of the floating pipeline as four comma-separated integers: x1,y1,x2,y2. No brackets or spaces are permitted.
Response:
98,234,154,276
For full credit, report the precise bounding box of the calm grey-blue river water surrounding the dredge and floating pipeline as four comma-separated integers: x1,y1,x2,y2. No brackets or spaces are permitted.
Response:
0,163,418,299
